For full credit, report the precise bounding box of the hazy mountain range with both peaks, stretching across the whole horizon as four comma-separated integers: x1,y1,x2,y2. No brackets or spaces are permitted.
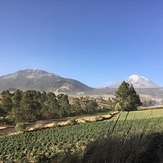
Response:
0,69,163,99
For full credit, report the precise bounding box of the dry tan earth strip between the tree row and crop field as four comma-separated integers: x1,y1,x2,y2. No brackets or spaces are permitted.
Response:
0,112,119,136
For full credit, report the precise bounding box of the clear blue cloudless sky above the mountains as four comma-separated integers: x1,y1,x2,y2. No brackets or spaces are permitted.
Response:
0,0,163,87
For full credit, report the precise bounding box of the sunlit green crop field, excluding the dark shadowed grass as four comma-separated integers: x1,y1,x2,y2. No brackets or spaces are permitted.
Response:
0,109,163,163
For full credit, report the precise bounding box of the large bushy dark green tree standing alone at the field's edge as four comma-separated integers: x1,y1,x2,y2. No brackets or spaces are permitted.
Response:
114,81,142,111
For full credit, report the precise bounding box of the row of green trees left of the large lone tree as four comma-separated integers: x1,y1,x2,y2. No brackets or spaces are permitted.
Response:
0,90,104,123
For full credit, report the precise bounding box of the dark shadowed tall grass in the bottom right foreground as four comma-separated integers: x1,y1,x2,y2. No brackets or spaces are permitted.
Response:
82,132,163,163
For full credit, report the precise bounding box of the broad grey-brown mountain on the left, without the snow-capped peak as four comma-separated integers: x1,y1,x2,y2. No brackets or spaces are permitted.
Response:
0,69,92,94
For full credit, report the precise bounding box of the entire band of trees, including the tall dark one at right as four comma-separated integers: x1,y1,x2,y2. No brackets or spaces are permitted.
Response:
0,81,142,123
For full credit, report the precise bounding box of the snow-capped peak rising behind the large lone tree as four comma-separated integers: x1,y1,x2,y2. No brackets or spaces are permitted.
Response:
111,75,160,88
